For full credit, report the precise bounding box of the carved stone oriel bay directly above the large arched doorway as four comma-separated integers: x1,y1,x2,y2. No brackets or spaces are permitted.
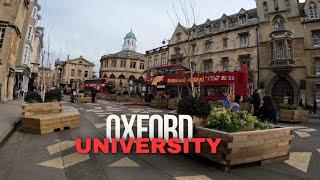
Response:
270,49,295,73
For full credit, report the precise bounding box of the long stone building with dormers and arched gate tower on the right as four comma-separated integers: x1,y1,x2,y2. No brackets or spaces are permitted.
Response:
147,0,320,106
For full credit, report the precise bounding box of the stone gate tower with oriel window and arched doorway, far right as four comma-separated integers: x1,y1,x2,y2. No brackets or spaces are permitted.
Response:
257,0,320,106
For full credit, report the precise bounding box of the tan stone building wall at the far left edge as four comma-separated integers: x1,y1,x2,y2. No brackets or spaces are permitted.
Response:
0,0,30,101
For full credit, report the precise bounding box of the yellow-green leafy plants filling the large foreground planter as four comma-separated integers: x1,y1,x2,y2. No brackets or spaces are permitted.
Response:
207,108,268,133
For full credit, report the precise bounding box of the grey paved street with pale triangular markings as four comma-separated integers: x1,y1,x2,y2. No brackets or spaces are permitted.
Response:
0,101,320,180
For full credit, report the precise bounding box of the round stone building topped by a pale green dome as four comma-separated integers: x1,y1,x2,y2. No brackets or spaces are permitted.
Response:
99,30,145,91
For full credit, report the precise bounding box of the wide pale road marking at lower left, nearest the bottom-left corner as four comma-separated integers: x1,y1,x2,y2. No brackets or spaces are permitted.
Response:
38,153,90,169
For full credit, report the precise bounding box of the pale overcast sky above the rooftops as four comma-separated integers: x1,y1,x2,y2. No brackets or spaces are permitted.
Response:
39,0,304,71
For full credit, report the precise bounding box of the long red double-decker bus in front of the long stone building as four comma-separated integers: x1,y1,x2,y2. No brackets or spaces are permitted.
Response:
146,65,249,101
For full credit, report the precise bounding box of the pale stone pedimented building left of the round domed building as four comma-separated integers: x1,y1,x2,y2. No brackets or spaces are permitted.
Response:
53,56,94,89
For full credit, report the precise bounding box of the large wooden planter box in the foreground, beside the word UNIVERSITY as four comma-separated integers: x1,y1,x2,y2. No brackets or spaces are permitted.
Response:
194,126,293,171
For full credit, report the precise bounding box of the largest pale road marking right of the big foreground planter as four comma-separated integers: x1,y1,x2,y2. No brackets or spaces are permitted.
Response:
285,152,312,173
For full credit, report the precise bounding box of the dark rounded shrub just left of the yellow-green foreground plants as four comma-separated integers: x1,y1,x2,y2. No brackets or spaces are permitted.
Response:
178,96,211,118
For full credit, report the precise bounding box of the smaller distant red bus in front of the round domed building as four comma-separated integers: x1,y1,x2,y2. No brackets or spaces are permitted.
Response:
82,78,115,93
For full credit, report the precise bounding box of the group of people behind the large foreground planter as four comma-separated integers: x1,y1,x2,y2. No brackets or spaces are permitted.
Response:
229,90,278,124
